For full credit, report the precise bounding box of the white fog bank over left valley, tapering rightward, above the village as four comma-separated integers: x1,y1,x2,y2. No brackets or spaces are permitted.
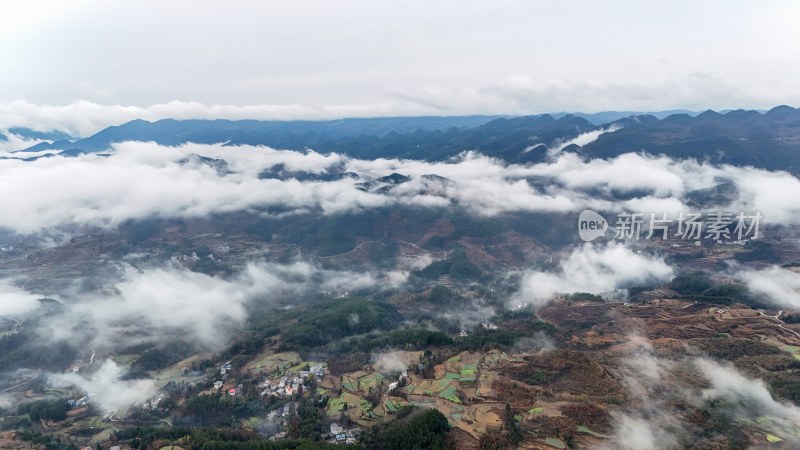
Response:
0,262,407,353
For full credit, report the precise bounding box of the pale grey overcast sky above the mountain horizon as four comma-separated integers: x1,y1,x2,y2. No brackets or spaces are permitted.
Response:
0,0,800,130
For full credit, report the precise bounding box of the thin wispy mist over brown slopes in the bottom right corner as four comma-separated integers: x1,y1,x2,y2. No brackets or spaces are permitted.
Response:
603,335,800,450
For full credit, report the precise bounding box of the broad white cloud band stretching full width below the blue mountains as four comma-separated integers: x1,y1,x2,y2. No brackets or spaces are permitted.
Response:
0,142,800,233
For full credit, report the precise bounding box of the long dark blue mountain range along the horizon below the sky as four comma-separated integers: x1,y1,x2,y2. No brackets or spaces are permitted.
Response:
14,105,800,173
